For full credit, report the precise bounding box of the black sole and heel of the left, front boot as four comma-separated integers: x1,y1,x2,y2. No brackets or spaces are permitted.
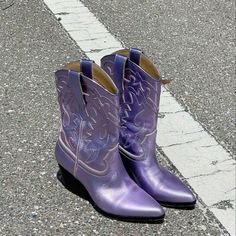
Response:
57,164,165,224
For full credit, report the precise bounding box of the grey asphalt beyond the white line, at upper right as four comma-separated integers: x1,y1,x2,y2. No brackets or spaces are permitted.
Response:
83,0,236,156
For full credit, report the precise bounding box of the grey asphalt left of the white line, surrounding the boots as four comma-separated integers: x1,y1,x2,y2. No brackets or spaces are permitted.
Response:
0,0,232,236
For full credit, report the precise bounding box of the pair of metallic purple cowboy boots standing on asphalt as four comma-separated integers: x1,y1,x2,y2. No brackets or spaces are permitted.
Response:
55,49,196,222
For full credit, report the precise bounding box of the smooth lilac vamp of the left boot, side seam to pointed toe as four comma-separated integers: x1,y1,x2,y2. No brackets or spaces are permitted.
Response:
76,152,164,217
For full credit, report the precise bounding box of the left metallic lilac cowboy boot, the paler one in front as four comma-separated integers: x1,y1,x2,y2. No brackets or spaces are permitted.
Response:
55,59,164,222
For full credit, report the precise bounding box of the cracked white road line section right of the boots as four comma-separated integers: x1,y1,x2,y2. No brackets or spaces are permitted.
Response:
157,89,235,236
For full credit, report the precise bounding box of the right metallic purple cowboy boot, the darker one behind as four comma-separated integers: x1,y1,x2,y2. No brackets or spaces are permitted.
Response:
101,49,196,209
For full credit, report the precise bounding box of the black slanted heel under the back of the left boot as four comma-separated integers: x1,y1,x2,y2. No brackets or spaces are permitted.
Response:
57,165,90,200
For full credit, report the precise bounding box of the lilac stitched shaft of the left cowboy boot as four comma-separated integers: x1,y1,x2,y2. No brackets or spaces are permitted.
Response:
56,60,119,174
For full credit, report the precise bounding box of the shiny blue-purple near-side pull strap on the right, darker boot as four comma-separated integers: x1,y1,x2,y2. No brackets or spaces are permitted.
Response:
112,54,127,93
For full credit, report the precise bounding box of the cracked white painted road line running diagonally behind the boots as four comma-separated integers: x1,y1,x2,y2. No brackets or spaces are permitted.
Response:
44,0,235,235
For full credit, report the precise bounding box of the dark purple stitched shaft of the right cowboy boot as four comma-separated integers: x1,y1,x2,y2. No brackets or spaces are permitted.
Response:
102,50,161,159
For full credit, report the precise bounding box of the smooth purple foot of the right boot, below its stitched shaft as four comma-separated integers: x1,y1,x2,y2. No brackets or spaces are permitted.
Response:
126,158,195,203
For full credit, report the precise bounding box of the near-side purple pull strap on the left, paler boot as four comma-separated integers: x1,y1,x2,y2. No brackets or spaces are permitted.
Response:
68,70,88,120
